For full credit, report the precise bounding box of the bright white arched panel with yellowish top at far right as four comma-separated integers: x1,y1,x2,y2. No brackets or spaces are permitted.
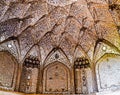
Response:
96,54,120,91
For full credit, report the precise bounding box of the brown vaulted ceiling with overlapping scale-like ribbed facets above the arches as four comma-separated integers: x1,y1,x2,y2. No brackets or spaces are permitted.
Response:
0,0,120,63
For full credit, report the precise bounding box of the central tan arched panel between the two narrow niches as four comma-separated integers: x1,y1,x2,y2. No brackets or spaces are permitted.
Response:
43,61,71,93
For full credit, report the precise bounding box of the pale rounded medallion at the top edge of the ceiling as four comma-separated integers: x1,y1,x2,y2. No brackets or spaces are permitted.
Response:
46,0,77,6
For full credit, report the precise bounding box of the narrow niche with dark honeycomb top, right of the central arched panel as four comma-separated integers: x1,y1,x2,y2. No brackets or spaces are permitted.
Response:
74,57,93,94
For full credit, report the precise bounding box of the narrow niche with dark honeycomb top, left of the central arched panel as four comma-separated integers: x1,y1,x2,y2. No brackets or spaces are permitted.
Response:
20,55,40,93
